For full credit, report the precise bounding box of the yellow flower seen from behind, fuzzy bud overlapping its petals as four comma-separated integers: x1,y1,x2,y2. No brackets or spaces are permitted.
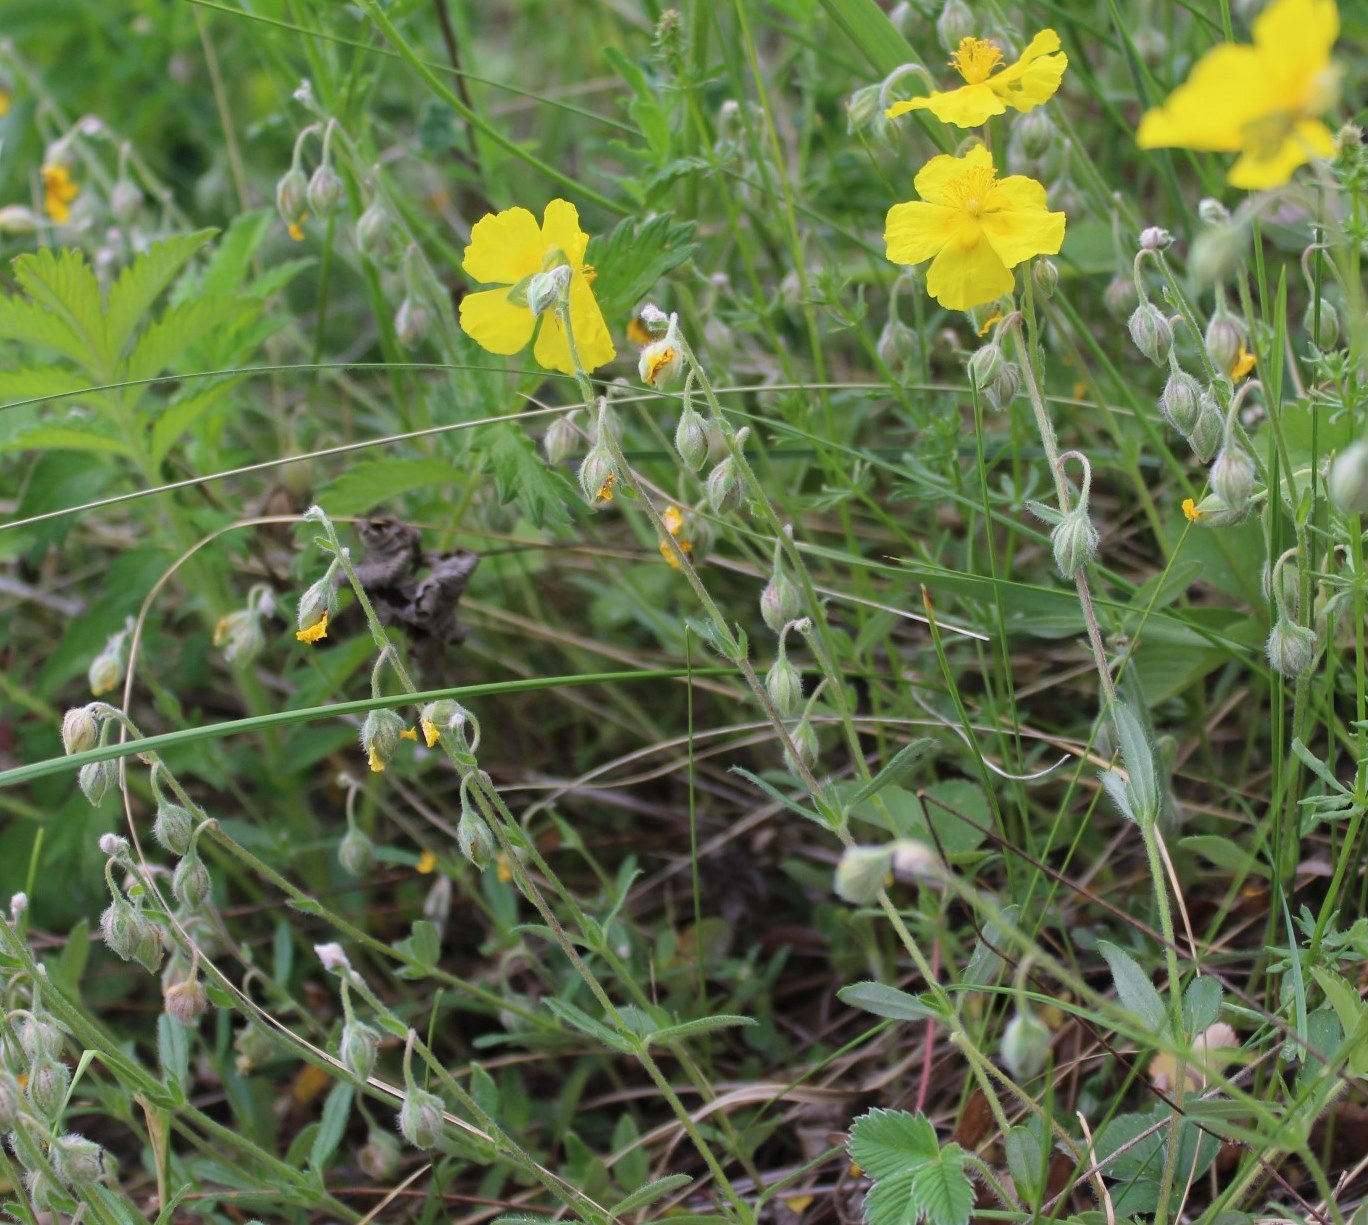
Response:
461,200,617,374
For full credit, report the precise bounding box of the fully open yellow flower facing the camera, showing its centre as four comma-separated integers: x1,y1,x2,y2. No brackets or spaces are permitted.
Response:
884,145,1064,311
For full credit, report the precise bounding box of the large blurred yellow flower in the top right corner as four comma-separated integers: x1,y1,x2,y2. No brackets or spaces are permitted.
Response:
1135,0,1339,189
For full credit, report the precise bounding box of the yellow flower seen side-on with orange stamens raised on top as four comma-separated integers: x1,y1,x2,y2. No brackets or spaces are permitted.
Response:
885,30,1068,127
